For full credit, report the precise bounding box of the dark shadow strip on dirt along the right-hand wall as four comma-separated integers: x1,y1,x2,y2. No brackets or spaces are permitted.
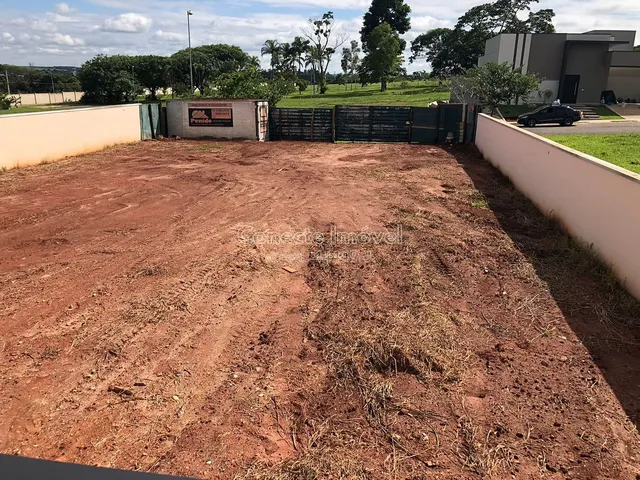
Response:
456,147,640,427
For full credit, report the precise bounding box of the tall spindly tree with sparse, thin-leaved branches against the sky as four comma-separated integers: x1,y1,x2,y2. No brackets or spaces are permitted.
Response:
302,11,346,94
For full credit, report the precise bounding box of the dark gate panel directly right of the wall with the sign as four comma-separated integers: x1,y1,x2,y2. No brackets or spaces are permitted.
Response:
269,108,333,142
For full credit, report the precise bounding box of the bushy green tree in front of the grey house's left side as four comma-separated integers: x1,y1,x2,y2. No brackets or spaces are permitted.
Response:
460,62,540,113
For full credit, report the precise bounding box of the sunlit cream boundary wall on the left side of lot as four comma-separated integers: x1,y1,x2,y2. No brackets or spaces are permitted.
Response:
0,103,140,168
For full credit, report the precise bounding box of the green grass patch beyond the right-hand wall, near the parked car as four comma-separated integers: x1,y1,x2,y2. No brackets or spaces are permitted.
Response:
547,134,640,173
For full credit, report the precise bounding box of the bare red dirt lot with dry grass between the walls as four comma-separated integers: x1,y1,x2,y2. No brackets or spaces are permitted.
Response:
0,141,640,480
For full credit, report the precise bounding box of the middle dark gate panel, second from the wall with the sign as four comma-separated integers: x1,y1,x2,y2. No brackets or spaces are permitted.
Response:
335,105,411,143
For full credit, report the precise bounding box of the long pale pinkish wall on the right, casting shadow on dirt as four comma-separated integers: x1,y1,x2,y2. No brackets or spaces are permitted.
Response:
476,114,640,299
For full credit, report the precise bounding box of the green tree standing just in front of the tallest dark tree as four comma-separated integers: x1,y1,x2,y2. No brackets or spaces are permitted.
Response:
361,22,402,92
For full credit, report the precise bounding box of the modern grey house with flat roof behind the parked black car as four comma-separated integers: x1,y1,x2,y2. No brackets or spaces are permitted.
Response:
478,30,640,103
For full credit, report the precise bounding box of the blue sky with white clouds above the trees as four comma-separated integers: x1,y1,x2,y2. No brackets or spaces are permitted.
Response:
0,0,640,71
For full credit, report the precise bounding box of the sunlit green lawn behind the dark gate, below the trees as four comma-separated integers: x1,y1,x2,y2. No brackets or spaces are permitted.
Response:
278,82,450,108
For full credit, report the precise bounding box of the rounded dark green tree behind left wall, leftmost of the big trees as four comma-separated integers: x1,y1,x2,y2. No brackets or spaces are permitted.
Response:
78,55,141,105
